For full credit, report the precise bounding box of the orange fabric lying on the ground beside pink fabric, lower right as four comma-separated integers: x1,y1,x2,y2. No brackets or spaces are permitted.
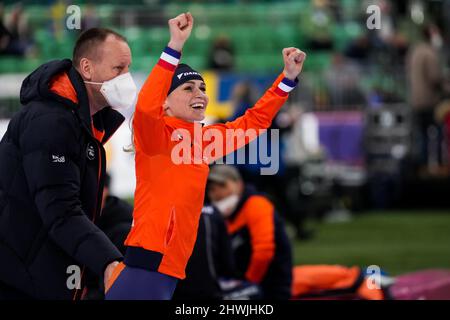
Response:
292,265,383,300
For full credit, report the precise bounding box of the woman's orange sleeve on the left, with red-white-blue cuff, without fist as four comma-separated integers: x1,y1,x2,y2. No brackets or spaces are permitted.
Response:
133,47,181,155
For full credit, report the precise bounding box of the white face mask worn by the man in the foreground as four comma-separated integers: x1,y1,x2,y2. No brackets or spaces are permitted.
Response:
85,72,137,110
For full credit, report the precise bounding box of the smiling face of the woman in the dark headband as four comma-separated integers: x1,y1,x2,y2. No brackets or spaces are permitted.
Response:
164,80,209,122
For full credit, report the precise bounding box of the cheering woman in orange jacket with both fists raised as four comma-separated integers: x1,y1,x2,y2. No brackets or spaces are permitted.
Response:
106,13,306,299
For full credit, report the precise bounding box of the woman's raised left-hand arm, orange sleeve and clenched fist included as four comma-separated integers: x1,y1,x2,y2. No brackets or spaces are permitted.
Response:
133,13,194,154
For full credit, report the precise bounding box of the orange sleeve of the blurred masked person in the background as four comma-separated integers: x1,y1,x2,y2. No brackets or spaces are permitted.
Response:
245,196,275,283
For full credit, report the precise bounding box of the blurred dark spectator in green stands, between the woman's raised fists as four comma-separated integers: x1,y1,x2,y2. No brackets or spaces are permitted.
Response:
208,36,234,71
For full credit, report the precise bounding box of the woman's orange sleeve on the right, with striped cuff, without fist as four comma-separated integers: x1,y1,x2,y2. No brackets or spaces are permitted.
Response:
203,74,297,162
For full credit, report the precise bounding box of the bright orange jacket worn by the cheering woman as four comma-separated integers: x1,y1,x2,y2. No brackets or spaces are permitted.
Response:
125,58,287,279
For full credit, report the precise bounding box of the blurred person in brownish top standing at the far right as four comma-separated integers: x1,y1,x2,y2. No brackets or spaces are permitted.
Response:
407,24,444,169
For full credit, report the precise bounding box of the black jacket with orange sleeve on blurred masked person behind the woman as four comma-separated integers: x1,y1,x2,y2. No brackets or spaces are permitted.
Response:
226,185,292,300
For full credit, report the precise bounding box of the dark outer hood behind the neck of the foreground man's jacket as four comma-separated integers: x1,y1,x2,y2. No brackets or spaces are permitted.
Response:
20,59,72,105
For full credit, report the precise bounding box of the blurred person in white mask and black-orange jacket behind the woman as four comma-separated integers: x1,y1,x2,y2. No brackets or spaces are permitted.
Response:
207,165,292,299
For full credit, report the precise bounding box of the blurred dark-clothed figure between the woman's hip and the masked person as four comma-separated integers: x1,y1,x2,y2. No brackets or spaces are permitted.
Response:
173,205,235,300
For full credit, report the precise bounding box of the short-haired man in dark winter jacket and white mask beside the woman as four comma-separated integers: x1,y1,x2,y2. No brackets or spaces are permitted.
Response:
0,29,136,299
